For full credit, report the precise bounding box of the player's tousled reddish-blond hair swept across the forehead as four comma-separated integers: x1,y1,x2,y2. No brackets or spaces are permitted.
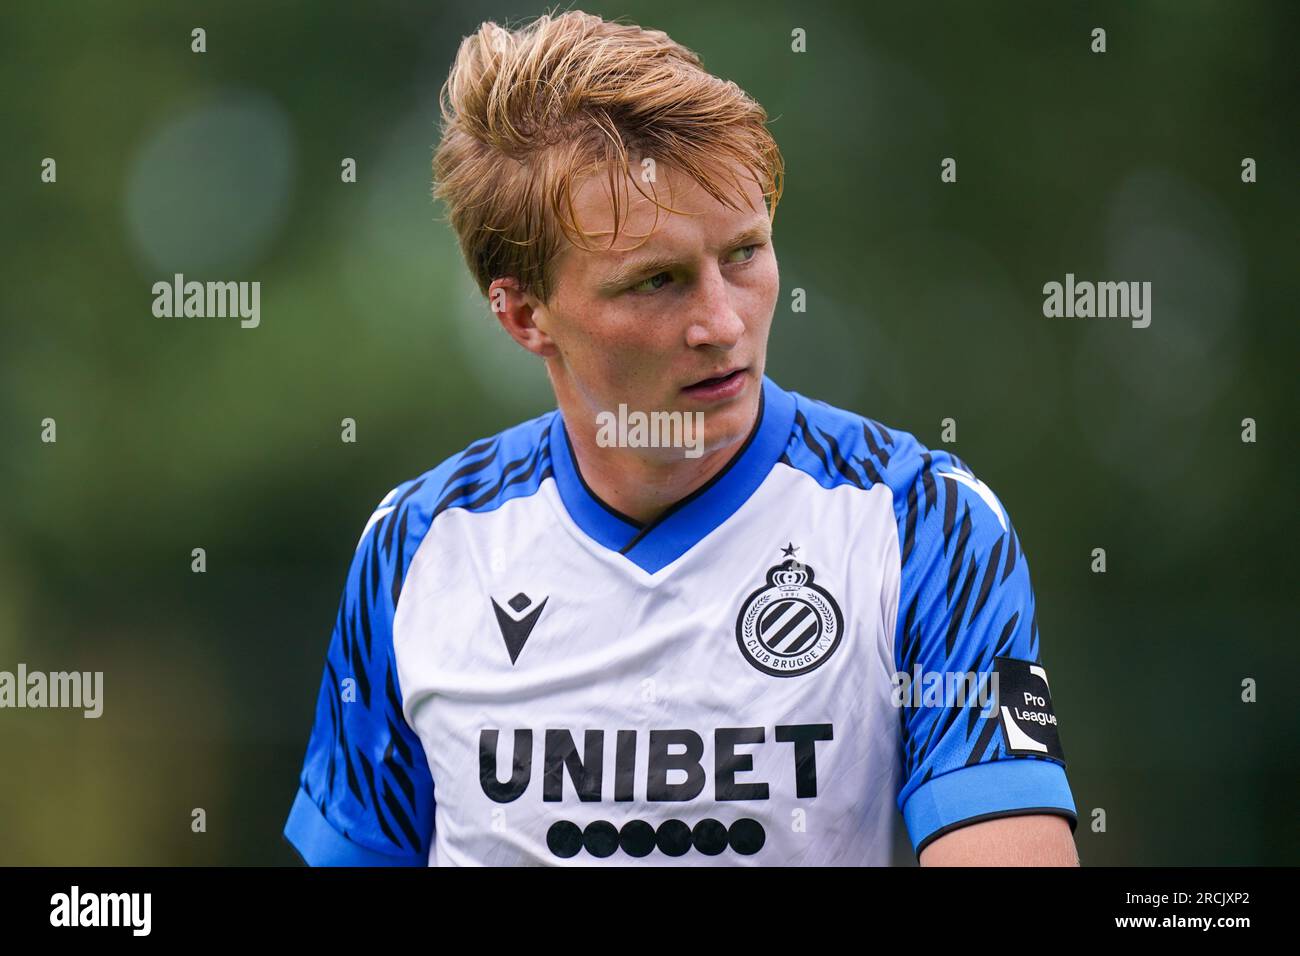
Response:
433,10,784,302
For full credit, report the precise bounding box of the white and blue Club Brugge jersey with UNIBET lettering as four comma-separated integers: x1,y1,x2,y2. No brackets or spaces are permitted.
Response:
285,378,1076,866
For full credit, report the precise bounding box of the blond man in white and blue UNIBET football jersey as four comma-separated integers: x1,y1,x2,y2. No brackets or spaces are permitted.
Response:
285,12,1076,865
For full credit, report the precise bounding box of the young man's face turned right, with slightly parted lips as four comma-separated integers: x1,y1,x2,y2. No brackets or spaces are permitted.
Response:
517,164,780,460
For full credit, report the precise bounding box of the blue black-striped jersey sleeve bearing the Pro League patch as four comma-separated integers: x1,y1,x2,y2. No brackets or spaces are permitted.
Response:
894,440,1078,856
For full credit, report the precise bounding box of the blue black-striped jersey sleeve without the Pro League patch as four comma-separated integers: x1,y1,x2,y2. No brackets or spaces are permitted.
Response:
283,488,434,866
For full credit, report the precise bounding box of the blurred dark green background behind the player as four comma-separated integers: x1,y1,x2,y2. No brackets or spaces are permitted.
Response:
0,3,1300,865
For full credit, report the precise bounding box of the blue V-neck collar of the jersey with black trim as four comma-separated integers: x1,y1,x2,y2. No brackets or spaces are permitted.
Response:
550,375,794,574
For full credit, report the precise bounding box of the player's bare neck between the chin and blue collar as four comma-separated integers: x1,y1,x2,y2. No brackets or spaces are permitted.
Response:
560,390,758,524
